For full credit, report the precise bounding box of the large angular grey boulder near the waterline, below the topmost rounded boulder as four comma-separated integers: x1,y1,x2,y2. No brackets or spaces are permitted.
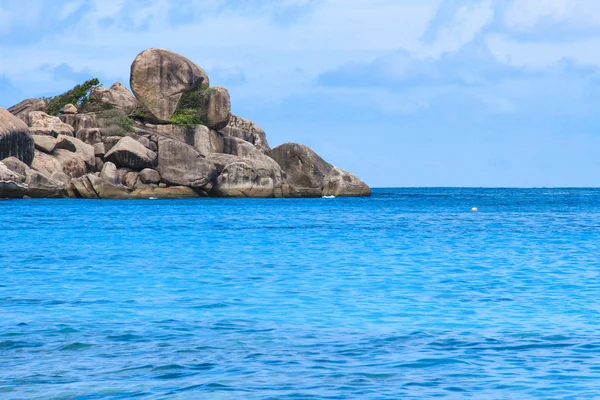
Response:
157,138,217,189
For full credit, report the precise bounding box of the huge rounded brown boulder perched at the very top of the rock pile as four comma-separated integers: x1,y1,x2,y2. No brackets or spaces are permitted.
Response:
130,49,209,122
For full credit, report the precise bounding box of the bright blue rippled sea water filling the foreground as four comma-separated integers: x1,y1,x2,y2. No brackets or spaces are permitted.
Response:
0,189,600,399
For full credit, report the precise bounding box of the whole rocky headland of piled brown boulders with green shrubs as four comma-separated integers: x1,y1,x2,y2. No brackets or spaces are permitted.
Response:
0,49,371,199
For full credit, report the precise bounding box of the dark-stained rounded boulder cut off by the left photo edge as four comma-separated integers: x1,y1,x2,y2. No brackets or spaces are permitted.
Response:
0,107,35,165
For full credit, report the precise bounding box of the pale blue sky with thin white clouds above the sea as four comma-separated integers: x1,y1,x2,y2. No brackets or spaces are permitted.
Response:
0,0,600,187
